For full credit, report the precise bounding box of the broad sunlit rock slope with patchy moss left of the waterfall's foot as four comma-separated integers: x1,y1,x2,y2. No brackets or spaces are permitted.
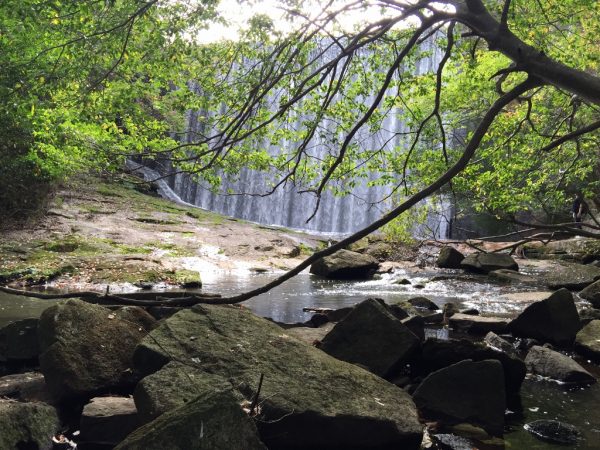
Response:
0,177,324,290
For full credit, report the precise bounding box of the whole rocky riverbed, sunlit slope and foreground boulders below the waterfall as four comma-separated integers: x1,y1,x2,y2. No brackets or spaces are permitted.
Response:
0,174,600,449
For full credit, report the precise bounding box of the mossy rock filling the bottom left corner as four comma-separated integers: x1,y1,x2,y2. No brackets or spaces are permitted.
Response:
0,399,59,450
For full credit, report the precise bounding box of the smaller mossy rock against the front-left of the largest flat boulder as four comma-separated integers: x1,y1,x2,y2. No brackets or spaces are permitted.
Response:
133,362,231,423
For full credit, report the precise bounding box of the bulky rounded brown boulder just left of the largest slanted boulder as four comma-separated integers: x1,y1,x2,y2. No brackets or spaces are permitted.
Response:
38,299,155,398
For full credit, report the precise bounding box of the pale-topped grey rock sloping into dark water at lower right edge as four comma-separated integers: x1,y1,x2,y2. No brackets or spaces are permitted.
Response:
525,345,596,384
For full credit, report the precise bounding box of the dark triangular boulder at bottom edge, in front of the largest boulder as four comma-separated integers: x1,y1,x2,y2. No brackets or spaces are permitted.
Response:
115,390,266,450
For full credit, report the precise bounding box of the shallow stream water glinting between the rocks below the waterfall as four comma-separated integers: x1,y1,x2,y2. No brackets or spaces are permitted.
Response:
0,269,600,450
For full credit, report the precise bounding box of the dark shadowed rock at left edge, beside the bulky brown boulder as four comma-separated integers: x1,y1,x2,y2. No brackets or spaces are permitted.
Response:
0,319,40,361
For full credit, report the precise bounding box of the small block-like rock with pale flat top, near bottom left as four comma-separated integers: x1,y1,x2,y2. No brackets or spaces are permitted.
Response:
78,397,141,447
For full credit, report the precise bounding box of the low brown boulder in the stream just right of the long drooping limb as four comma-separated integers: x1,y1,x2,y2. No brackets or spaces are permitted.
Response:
310,250,379,280
